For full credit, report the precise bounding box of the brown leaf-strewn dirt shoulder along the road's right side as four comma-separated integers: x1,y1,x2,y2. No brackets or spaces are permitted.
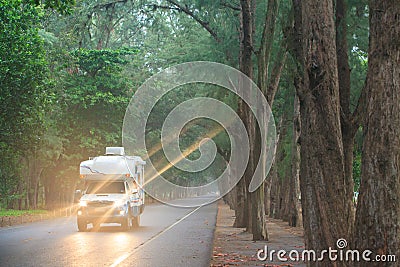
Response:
210,201,306,267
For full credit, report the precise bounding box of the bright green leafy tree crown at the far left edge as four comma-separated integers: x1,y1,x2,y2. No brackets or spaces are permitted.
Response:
0,0,47,150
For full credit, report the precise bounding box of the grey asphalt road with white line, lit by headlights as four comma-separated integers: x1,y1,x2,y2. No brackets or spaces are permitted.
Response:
0,198,217,267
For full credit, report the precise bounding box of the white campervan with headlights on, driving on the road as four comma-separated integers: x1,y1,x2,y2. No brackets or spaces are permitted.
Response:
77,147,146,231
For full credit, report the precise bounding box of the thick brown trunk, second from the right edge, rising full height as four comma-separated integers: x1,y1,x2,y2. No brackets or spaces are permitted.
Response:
293,0,352,266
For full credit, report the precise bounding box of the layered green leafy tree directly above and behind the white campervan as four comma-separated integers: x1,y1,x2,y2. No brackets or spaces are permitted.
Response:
59,49,135,157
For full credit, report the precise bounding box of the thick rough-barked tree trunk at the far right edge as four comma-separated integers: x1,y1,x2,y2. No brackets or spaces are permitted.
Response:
354,0,400,266
